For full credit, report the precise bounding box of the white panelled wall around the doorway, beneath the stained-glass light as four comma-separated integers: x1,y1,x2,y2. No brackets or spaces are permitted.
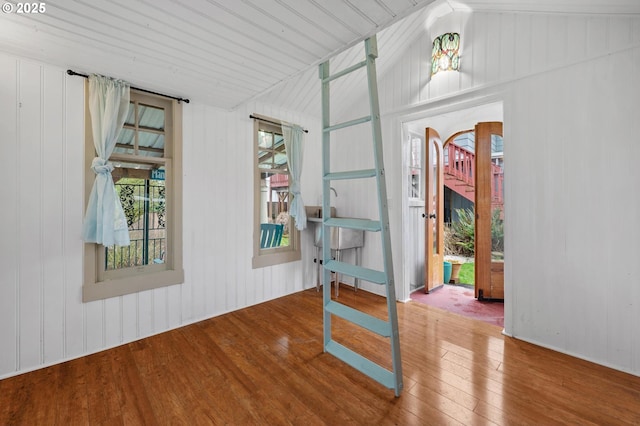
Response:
324,12,640,375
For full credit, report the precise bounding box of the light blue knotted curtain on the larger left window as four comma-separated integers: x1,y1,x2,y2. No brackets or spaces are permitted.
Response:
82,74,130,246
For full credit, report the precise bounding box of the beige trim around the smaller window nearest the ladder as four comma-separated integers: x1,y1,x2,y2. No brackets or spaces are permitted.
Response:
251,114,302,269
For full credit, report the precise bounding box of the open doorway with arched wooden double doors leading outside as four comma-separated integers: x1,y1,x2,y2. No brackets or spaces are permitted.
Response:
403,103,505,325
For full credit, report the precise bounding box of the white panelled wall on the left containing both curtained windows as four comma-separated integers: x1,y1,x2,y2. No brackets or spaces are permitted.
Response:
0,54,320,378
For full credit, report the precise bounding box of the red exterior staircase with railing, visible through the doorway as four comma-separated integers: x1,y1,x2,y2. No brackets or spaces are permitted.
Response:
444,142,504,211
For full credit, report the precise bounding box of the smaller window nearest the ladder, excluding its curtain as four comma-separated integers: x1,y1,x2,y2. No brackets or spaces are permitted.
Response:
252,114,301,268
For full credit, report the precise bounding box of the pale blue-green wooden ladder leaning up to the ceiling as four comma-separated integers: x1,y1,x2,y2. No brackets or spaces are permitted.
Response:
320,35,402,396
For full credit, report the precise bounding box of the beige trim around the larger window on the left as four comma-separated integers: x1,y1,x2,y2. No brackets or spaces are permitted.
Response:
82,84,184,302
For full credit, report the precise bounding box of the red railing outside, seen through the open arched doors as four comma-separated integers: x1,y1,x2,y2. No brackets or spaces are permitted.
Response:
444,143,504,205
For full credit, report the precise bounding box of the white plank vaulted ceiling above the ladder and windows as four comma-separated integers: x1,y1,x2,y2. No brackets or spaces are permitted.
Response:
0,0,640,109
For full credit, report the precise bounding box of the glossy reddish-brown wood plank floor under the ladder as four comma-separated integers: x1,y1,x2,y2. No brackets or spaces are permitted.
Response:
0,288,640,425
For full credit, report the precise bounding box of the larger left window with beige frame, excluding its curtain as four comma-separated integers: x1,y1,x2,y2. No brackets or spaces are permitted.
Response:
83,90,184,302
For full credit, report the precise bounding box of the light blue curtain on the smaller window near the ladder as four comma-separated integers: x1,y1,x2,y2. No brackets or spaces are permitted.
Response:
282,122,307,231
